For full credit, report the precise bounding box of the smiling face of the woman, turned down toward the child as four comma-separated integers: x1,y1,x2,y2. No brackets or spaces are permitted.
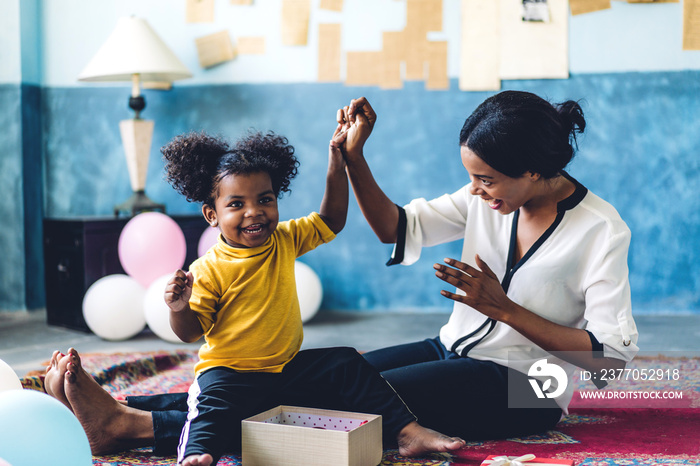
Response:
460,146,535,215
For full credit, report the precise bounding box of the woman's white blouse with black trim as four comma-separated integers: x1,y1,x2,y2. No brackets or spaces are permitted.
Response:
394,179,639,412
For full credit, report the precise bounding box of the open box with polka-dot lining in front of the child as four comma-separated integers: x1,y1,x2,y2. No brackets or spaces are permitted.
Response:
242,406,383,466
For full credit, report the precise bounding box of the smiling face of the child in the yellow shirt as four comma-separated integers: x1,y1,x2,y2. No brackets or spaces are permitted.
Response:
204,172,279,248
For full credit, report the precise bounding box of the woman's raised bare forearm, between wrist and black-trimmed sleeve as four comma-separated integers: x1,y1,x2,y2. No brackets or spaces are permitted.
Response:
347,155,399,243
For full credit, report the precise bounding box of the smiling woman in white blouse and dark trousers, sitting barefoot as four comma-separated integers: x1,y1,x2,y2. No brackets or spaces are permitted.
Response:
47,91,638,453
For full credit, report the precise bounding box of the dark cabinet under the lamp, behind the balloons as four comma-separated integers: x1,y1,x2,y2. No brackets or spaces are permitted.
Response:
44,215,208,332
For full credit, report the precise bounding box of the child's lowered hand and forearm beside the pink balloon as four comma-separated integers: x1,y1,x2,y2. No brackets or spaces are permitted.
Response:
165,270,204,343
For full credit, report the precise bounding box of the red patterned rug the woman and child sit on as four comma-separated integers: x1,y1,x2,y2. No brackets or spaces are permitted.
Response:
22,350,700,466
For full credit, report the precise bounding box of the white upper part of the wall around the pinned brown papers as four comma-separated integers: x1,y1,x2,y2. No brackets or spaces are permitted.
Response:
28,0,700,86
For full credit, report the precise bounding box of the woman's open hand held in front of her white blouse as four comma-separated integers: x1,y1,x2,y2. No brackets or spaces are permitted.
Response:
433,254,512,321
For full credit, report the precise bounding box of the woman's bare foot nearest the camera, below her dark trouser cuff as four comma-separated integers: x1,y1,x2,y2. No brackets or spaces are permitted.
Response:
64,348,154,455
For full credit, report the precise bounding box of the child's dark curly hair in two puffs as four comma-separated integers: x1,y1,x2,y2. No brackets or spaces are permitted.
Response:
160,131,299,206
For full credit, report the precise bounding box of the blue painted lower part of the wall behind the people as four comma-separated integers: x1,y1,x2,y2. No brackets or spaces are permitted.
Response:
39,71,700,313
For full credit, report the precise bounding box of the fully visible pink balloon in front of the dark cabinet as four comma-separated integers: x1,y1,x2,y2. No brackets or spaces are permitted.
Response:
119,212,187,288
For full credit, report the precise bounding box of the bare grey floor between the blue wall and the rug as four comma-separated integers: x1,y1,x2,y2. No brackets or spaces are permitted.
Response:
0,311,700,377
